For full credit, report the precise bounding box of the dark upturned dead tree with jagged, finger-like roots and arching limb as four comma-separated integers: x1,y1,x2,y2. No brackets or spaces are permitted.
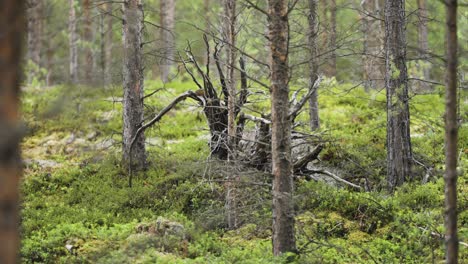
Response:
131,33,321,170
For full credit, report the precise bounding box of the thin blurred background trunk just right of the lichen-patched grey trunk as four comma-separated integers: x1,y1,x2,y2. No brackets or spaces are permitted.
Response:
418,0,430,90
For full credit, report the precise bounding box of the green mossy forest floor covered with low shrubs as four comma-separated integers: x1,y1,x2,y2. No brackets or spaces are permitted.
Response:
21,80,468,263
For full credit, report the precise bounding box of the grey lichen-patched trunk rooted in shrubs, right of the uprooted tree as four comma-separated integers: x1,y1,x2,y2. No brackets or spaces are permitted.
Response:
385,0,412,191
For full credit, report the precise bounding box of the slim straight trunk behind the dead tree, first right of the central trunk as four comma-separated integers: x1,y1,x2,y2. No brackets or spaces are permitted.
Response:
308,0,320,130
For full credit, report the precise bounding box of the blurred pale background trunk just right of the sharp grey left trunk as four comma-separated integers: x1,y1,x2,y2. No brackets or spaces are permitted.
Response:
160,0,176,82
